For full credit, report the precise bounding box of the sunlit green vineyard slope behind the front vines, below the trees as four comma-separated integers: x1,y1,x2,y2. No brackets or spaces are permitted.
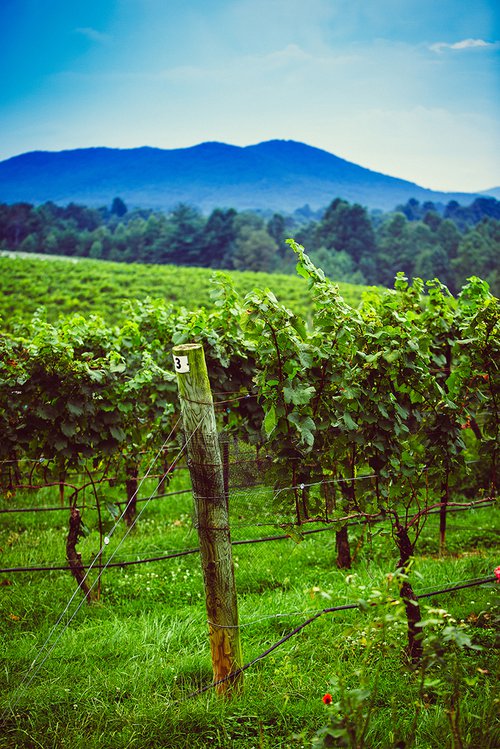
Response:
0,253,365,329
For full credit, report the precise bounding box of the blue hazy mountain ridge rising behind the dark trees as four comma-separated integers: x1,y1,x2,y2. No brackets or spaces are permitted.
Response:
0,140,492,212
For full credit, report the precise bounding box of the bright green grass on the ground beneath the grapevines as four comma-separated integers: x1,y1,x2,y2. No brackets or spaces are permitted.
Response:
0,472,500,749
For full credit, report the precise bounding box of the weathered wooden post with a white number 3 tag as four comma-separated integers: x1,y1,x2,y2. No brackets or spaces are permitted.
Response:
173,343,243,696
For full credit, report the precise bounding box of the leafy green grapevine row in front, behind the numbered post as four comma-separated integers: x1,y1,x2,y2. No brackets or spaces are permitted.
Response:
0,240,500,660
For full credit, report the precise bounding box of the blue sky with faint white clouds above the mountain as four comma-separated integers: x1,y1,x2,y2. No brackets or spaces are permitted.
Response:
0,0,500,192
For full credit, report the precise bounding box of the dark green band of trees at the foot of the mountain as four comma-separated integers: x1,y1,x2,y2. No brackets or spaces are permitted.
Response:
0,197,500,294
